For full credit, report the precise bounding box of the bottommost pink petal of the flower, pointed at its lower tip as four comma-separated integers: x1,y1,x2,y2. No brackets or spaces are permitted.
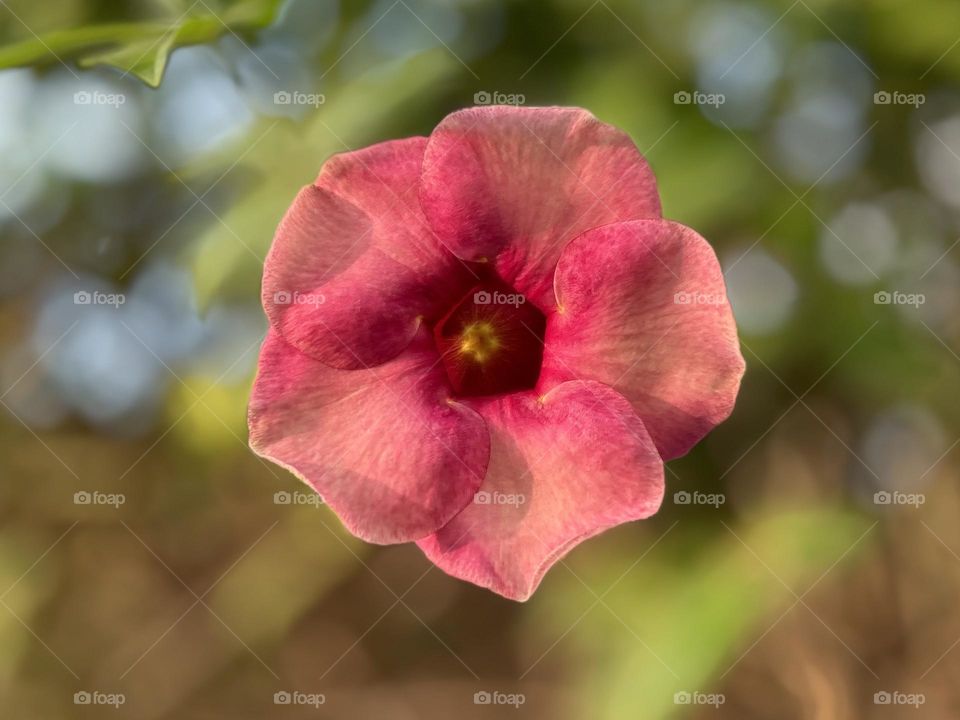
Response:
418,381,663,600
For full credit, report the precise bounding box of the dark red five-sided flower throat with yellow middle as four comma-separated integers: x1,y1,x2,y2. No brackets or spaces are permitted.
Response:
433,281,547,397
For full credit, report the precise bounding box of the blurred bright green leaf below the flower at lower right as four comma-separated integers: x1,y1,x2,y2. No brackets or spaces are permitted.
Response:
536,510,868,720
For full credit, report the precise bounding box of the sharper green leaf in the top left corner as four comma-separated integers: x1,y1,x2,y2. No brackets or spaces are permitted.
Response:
0,0,280,87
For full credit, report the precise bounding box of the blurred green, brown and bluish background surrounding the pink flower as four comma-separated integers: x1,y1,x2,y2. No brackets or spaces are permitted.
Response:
0,0,960,720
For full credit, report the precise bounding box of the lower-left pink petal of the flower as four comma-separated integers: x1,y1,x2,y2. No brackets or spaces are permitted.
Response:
249,329,490,543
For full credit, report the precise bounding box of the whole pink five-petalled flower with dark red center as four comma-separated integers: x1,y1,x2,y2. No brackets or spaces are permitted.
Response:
249,107,744,600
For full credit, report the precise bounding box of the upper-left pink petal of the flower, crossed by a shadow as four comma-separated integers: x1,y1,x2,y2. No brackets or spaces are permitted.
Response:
263,137,469,368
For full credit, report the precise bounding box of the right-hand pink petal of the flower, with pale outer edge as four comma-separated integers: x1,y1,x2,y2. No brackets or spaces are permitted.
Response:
538,219,744,460
